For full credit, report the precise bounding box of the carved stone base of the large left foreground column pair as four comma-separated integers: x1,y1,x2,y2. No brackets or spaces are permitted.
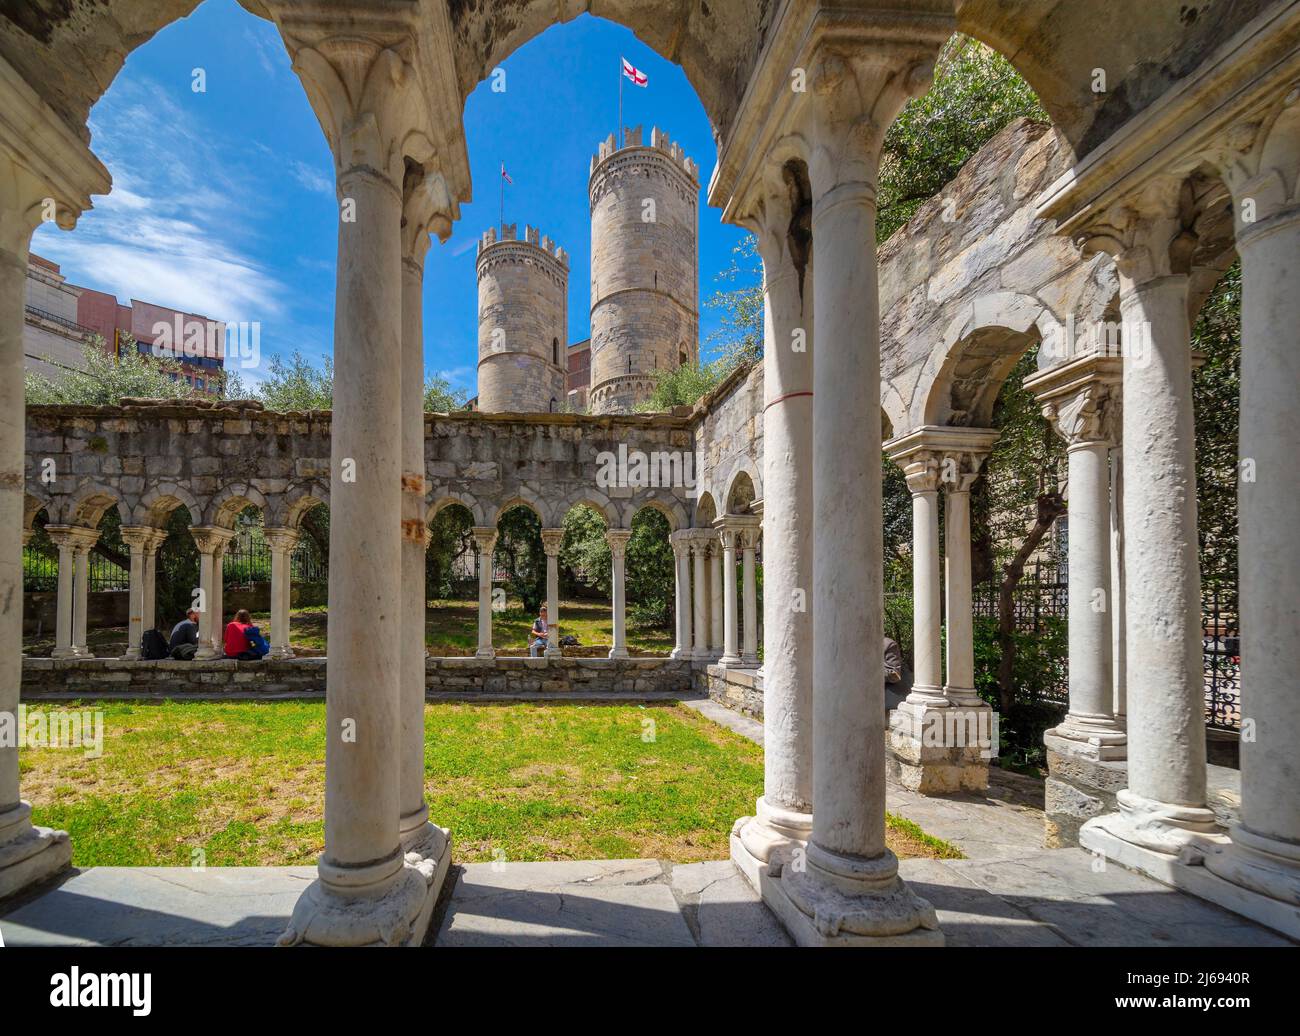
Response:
277,853,451,946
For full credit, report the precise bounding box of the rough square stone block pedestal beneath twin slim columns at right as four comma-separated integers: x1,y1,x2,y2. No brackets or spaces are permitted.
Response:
885,699,998,796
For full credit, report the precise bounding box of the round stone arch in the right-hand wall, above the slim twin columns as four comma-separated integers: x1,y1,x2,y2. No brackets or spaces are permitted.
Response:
915,291,1057,433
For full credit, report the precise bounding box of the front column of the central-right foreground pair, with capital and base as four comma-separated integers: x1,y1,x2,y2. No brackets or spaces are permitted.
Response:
763,30,952,945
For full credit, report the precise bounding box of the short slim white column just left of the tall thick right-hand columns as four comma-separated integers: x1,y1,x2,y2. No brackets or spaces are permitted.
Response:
1058,441,1118,738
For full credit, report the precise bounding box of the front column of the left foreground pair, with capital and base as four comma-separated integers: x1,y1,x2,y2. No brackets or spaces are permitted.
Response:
268,24,447,945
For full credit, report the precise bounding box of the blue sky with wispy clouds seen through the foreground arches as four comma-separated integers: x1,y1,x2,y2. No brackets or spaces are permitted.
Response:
33,0,742,394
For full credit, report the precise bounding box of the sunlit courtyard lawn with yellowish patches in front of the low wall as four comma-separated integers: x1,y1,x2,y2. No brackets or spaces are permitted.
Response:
20,702,959,867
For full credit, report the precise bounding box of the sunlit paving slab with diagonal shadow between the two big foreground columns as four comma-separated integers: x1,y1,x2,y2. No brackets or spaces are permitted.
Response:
436,859,696,946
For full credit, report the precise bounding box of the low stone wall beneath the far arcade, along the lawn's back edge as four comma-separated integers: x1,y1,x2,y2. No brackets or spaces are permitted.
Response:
22,658,693,702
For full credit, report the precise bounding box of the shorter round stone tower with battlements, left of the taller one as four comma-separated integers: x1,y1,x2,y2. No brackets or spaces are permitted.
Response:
477,224,568,413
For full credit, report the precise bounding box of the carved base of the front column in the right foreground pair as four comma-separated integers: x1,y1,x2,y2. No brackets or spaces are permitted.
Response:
762,842,944,946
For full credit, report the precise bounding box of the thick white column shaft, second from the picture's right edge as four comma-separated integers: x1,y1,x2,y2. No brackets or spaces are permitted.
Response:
1121,274,1205,809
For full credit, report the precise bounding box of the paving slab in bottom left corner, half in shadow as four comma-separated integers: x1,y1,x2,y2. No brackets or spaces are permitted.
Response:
0,867,316,946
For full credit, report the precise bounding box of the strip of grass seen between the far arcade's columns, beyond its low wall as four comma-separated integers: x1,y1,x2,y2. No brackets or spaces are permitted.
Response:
23,601,673,658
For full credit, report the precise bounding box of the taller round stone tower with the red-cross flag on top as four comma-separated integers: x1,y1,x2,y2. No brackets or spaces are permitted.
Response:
588,126,699,413
